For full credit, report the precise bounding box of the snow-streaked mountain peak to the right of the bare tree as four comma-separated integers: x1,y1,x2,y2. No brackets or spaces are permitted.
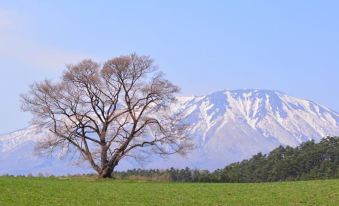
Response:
160,90,339,169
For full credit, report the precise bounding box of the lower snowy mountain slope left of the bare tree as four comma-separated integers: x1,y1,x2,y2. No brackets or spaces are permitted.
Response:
0,127,91,175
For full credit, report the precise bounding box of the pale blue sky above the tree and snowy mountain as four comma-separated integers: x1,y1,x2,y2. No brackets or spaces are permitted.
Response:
0,0,339,134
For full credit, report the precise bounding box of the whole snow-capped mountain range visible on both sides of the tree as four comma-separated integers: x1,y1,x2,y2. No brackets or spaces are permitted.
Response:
0,90,339,175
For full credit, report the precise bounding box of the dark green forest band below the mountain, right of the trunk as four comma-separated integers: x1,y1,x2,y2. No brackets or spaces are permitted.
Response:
114,137,339,183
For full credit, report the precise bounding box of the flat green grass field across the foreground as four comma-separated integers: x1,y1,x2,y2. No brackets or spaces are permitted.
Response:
0,177,339,206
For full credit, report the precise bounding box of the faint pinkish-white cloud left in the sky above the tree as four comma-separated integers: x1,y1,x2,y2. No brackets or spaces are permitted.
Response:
0,10,88,69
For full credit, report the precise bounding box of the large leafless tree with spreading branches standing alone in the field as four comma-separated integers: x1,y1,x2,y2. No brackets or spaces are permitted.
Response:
22,54,192,178
